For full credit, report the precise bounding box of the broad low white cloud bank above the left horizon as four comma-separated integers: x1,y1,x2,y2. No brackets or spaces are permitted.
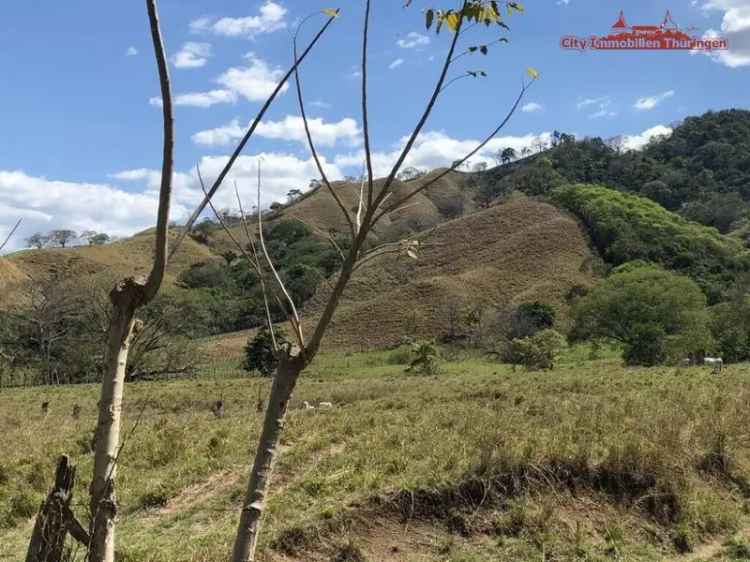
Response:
0,152,343,251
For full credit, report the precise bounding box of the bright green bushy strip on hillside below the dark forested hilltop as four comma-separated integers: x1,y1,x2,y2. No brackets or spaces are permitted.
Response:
554,185,750,302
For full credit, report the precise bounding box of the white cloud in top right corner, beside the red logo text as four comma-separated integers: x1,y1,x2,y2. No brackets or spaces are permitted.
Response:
701,0,750,68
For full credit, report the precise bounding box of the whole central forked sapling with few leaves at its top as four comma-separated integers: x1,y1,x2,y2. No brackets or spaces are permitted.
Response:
227,0,538,562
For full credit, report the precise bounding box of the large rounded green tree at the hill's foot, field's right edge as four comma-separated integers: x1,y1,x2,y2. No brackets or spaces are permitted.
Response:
573,266,713,365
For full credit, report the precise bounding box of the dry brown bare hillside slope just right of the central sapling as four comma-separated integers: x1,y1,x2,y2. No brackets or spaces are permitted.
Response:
305,197,594,349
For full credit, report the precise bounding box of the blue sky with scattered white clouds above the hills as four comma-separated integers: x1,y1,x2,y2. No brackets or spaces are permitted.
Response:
0,0,750,251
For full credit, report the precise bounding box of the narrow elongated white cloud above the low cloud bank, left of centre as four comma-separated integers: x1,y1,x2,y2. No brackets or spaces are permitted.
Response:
192,115,361,146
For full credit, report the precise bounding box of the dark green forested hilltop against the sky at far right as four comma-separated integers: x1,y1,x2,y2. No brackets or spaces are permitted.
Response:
477,109,750,233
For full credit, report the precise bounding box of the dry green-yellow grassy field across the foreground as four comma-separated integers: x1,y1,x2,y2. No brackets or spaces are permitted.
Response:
0,348,750,562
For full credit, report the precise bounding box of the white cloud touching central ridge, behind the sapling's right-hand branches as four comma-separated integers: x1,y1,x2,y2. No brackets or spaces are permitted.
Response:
334,131,552,176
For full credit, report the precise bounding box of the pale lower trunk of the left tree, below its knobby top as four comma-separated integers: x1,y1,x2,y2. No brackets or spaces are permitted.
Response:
89,279,143,562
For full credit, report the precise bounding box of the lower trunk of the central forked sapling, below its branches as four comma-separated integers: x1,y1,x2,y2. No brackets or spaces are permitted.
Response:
232,354,305,562
